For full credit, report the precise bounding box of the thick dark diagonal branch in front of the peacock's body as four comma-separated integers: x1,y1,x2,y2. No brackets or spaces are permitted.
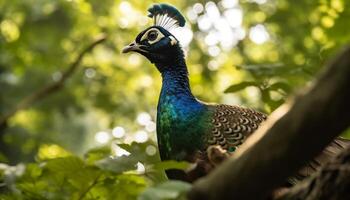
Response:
188,48,350,200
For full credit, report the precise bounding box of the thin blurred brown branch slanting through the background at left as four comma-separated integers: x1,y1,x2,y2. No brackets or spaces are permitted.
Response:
0,35,107,127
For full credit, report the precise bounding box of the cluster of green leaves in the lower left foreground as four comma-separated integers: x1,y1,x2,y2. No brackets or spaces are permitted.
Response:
0,143,190,200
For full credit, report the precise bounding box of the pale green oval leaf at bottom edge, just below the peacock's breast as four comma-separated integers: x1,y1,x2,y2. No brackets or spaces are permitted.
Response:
138,181,191,200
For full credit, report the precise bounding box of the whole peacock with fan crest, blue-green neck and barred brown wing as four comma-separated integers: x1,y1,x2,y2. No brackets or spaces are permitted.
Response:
122,4,349,182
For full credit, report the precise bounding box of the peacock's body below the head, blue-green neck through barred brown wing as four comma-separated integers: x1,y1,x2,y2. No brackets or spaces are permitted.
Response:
157,53,266,180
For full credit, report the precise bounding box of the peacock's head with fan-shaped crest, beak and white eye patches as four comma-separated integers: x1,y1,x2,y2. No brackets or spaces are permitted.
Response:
122,4,185,67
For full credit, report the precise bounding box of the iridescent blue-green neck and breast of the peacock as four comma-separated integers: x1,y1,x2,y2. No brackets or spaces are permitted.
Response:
157,62,208,160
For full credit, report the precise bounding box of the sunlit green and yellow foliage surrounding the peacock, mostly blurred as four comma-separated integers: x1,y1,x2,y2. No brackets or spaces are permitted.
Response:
0,0,350,199
